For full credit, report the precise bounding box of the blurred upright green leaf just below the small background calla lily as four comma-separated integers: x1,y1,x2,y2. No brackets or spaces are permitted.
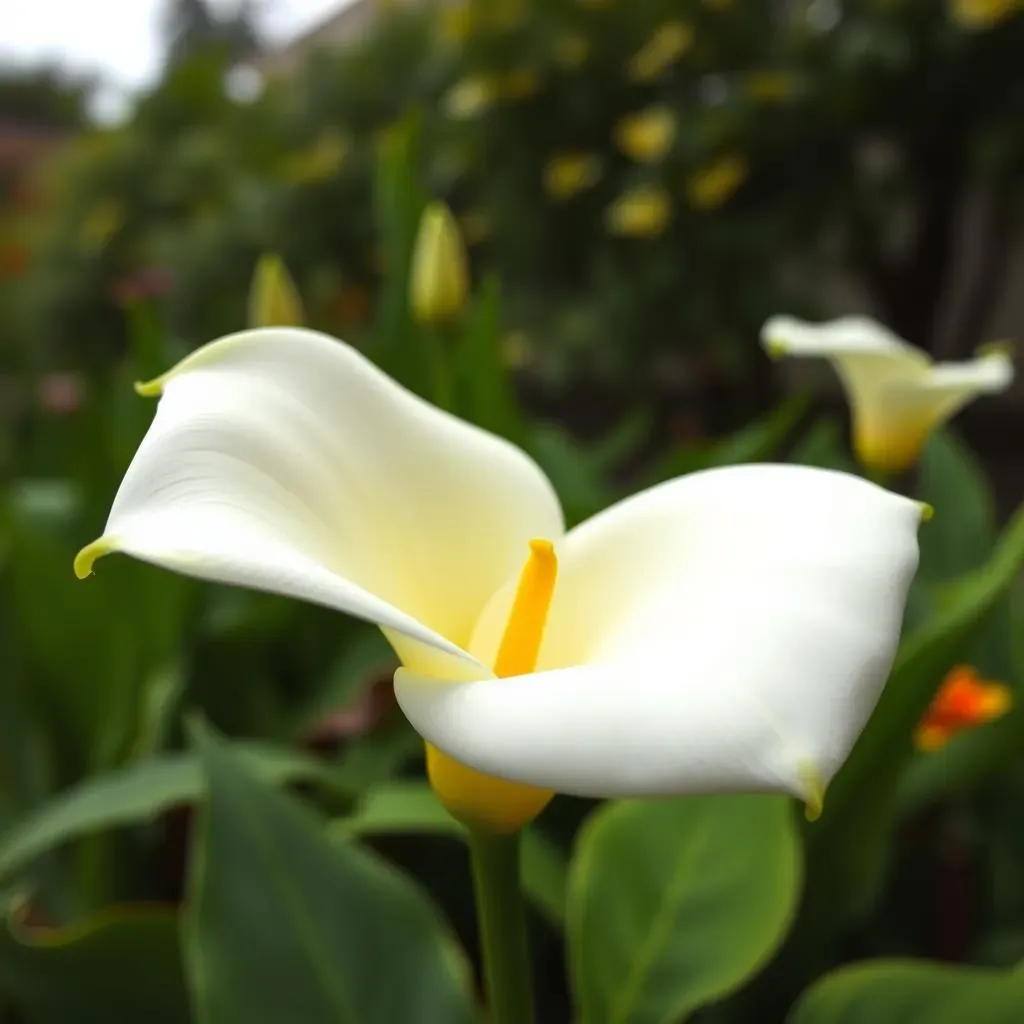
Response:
916,430,998,581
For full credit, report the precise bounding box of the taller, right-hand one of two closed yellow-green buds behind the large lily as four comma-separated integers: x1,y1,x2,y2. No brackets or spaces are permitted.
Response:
412,203,469,325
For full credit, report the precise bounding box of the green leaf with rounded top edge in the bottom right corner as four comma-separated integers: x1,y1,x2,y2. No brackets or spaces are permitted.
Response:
788,961,1024,1024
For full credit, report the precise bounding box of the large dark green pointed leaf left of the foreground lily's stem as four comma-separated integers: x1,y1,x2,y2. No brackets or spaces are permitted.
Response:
185,729,476,1024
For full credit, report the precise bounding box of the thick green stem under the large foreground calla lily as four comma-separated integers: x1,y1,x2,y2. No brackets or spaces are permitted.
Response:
469,828,534,1024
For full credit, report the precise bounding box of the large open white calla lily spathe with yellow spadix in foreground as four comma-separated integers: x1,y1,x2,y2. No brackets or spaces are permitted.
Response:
76,329,922,813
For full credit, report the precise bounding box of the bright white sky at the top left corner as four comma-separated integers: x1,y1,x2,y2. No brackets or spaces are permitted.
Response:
0,0,348,116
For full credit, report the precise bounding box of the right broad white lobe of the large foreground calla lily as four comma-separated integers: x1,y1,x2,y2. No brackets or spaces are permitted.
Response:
395,466,922,800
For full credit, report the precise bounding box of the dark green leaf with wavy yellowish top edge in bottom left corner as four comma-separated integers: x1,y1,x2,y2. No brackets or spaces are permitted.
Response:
0,907,188,1024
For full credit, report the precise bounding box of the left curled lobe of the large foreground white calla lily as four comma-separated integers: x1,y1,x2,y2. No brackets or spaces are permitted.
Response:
77,328,562,652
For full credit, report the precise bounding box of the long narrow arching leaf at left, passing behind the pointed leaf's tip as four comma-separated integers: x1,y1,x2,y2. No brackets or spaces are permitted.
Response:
0,745,347,882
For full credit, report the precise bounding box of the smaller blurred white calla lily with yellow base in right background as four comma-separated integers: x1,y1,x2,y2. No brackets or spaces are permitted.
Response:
761,316,1014,472
